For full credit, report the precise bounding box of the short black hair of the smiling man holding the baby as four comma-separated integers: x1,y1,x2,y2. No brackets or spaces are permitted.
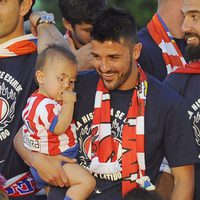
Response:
91,7,137,43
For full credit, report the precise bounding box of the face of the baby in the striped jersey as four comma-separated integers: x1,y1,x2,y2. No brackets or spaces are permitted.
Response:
43,59,77,101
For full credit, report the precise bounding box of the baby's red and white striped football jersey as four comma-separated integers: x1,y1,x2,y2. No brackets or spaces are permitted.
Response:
22,93,77,155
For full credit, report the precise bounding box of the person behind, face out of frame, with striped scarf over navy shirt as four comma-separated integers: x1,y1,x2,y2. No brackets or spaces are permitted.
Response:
138,0,186,81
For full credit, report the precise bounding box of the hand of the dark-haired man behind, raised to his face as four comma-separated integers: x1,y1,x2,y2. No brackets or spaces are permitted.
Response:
68,37,94,71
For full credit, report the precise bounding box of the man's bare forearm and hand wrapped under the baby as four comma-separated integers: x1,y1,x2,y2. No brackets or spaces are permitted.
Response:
14,128,76,187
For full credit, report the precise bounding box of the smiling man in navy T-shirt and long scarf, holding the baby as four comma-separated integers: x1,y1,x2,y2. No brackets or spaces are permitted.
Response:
15,8,197,200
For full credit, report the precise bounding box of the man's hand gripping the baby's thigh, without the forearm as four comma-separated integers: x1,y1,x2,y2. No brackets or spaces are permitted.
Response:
31,153,76,187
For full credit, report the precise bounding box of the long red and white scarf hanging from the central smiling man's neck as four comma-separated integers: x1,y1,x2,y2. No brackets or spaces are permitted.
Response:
90,68,155,196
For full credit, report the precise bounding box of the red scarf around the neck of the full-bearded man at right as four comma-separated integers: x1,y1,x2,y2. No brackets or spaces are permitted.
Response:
173,60,200,74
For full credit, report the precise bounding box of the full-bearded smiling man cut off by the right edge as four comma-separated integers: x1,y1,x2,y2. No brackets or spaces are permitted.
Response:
165,0,200,200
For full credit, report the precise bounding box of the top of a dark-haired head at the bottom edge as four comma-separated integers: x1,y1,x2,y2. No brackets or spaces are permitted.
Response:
123,188,162,200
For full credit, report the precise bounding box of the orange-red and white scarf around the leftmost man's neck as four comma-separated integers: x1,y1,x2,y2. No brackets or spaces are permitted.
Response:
0,34,37,58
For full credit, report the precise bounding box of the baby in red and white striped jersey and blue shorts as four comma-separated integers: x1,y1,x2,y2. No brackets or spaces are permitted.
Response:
22,45,96,200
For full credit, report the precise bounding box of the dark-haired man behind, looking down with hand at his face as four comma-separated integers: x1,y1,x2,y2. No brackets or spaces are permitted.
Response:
58,0,107,71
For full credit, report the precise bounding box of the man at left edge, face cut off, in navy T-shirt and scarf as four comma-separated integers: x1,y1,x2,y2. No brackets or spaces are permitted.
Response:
0,0,43,199
